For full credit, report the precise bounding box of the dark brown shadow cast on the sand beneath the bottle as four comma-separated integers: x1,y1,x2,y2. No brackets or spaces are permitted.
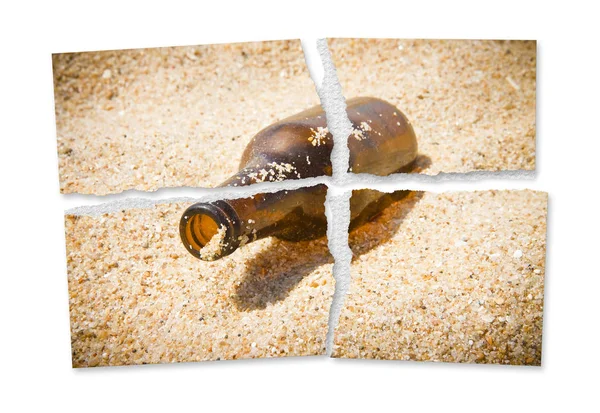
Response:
233,156,432,311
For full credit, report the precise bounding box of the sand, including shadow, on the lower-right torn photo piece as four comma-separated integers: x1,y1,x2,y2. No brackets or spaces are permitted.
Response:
333,190,547,365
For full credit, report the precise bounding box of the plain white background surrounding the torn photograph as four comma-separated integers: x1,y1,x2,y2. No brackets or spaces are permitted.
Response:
0,0,600,412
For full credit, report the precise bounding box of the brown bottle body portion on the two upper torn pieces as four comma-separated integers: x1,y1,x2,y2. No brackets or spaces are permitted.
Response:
220,97,418,186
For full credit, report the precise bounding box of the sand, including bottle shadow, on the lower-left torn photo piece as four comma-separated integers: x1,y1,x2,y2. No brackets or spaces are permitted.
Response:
65,203,334,367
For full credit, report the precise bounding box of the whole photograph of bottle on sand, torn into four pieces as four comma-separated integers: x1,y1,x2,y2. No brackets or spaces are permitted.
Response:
57,39,547,368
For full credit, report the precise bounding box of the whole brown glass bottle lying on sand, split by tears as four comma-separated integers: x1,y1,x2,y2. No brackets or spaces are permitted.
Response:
180,98,417,259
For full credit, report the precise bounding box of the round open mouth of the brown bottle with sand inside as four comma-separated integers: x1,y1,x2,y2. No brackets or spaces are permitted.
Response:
179,201,240,261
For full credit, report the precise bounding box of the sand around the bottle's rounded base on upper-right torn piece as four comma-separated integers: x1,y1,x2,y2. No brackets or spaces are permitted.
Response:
328,39,536,175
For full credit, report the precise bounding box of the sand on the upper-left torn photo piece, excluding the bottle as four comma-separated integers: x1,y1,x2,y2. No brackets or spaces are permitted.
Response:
53,40,319,195
